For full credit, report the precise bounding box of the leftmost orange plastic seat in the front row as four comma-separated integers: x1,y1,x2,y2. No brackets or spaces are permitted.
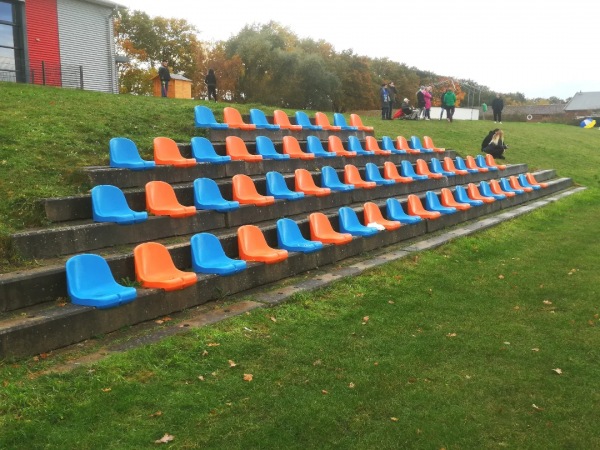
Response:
133,242,198,291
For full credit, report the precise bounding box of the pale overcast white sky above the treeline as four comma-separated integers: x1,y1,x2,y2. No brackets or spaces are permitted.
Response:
115,0,600,99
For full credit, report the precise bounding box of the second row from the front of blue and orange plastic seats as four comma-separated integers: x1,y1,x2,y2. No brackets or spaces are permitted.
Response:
91,157,537,225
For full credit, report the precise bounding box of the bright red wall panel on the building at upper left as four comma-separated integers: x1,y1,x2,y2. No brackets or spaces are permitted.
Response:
25,0,62,86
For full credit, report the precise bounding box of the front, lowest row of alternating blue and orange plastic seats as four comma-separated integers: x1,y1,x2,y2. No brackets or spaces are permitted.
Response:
66,174,546,308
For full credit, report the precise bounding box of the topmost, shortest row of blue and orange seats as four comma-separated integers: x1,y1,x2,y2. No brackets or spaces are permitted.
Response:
194,105,373,131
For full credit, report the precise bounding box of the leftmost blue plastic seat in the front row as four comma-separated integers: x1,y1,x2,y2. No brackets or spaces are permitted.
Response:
65,253,137,309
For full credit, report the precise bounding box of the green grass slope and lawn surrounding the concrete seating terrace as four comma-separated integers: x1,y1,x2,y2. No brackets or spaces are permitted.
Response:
0,84,600,449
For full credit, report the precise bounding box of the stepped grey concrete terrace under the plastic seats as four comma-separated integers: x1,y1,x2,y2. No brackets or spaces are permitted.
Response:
0,112,572,358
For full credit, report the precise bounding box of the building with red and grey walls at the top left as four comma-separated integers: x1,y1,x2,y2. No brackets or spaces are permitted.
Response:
0,0,118,93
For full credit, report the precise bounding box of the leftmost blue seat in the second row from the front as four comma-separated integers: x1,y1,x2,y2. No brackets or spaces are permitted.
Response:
91,184,148,225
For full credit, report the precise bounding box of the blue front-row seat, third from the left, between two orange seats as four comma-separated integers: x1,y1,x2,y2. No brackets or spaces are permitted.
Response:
190,233,247,275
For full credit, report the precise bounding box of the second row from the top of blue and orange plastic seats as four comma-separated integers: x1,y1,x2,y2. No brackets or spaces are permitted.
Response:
109,135,452,170
